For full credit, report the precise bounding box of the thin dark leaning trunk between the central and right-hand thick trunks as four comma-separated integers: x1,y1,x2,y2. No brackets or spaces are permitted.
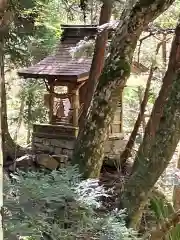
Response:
120,43,161,166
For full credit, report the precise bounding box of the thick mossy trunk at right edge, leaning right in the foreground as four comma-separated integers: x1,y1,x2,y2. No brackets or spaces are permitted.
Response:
119,19,180,229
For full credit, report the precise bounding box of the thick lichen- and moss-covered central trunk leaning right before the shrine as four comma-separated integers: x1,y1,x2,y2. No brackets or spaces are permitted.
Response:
73,0,174,178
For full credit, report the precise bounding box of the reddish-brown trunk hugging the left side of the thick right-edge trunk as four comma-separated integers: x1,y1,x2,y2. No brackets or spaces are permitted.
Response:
133,17,180,172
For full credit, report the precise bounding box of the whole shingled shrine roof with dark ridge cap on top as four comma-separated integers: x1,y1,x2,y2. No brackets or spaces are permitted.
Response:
18,25,148,82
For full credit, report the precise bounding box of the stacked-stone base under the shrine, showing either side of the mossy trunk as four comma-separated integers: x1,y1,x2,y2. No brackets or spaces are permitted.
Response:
32,125,126,159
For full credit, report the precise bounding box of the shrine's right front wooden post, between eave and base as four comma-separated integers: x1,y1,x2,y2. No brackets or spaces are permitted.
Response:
72,90,79,127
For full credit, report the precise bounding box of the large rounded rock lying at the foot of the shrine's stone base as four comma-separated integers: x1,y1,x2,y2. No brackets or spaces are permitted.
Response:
36,154,59,170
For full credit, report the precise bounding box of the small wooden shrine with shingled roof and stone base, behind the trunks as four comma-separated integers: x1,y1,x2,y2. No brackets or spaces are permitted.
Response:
18,25,148,158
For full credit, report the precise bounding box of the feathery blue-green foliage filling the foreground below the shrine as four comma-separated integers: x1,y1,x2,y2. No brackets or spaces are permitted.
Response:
4,167,139,240
